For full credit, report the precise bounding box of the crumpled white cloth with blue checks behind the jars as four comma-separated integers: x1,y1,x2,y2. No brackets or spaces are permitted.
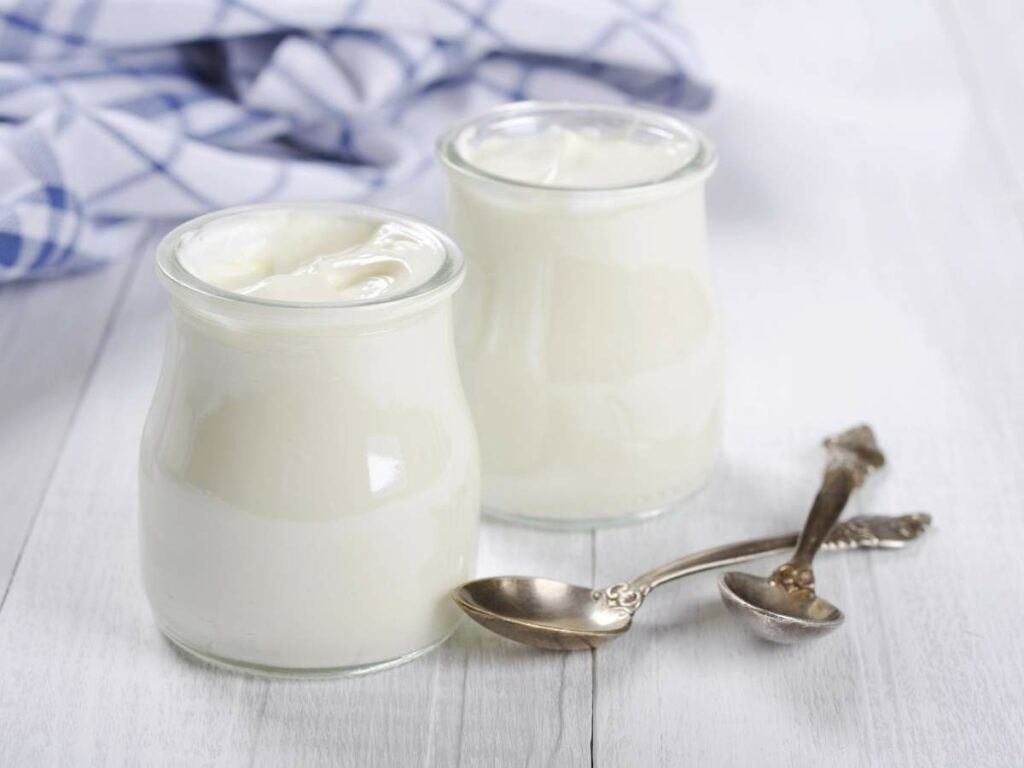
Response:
0,0,710,282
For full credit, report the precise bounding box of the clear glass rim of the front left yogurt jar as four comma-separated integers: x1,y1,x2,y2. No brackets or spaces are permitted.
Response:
157,201,466,318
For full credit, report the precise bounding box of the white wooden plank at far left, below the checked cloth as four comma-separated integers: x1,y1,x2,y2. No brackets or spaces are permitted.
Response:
0,250,131,593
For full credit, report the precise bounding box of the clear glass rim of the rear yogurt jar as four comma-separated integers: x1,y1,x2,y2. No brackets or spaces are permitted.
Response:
435,101,718,196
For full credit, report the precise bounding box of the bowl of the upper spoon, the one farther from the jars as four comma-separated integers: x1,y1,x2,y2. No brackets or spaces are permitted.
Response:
718,571,844,643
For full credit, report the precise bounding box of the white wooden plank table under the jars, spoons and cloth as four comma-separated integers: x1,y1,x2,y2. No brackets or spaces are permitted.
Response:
0,0,1024,767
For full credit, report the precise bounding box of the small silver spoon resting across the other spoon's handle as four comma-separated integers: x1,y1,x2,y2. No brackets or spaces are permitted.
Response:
718,425,885,643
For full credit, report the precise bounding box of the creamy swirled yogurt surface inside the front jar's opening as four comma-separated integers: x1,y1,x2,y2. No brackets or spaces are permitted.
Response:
177,210,444,303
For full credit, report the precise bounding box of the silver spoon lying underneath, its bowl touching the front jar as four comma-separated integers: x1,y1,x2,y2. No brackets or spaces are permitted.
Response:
452,513,932,650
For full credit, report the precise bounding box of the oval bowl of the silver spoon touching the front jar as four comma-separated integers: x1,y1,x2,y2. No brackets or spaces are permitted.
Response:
452,577,633,650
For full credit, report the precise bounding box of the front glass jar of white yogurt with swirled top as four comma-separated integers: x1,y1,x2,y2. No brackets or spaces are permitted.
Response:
140,204,479,675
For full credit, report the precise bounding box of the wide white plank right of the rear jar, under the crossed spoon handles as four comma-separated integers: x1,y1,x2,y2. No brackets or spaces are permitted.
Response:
595,2,1024,766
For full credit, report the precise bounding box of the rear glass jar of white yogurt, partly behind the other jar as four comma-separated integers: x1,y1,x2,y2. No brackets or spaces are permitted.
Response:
438,102,723,526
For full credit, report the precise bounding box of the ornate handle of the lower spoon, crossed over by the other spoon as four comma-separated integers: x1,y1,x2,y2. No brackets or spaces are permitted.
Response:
629,512,932,596
